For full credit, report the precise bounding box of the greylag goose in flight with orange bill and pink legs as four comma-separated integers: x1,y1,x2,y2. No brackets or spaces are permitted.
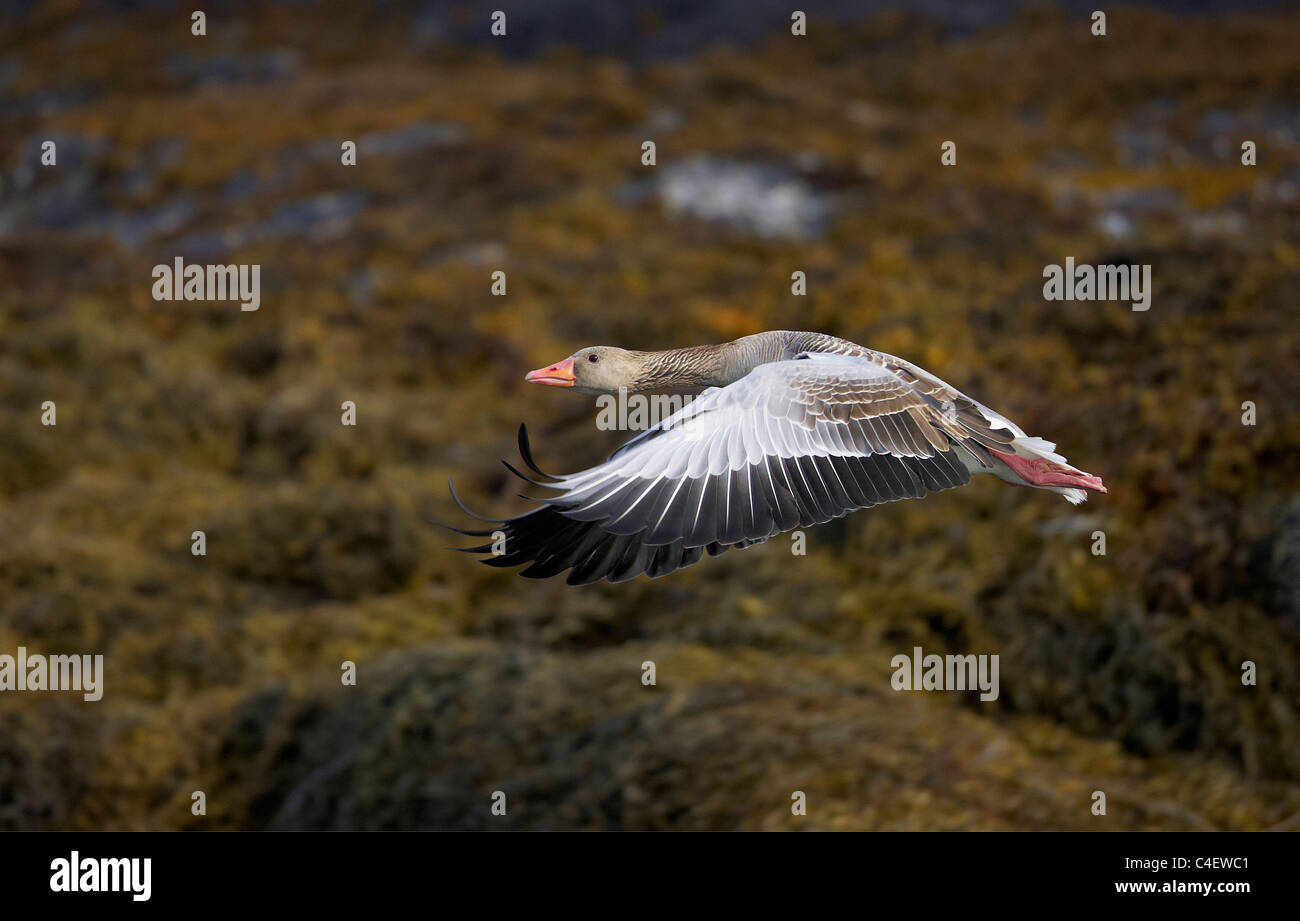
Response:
443,330,1106,584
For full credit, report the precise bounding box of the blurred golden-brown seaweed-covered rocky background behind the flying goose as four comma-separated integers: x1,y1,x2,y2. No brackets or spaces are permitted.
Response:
0,0,1300,830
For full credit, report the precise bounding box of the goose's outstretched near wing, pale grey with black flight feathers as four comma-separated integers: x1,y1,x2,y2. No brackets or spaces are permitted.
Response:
447,353,1019,583
